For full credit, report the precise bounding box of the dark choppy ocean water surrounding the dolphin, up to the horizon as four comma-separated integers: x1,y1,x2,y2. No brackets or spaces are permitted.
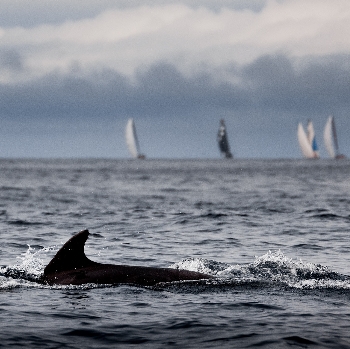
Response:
0,160,350,348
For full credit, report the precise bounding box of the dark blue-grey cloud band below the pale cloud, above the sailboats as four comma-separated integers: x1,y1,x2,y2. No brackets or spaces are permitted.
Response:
0,55,350,118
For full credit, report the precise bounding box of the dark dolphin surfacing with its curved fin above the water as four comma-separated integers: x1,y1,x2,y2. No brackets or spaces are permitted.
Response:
42,230,213,286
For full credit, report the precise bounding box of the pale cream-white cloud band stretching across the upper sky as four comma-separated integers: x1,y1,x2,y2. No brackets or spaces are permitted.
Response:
0,0,350,83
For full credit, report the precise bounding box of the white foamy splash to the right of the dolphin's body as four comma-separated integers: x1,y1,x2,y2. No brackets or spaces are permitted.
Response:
170,250,350,289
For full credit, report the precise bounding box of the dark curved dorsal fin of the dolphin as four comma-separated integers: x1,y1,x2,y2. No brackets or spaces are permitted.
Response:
44,230,98,275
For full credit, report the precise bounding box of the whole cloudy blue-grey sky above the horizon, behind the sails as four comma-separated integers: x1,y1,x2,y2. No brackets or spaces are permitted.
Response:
0,0,350,159
